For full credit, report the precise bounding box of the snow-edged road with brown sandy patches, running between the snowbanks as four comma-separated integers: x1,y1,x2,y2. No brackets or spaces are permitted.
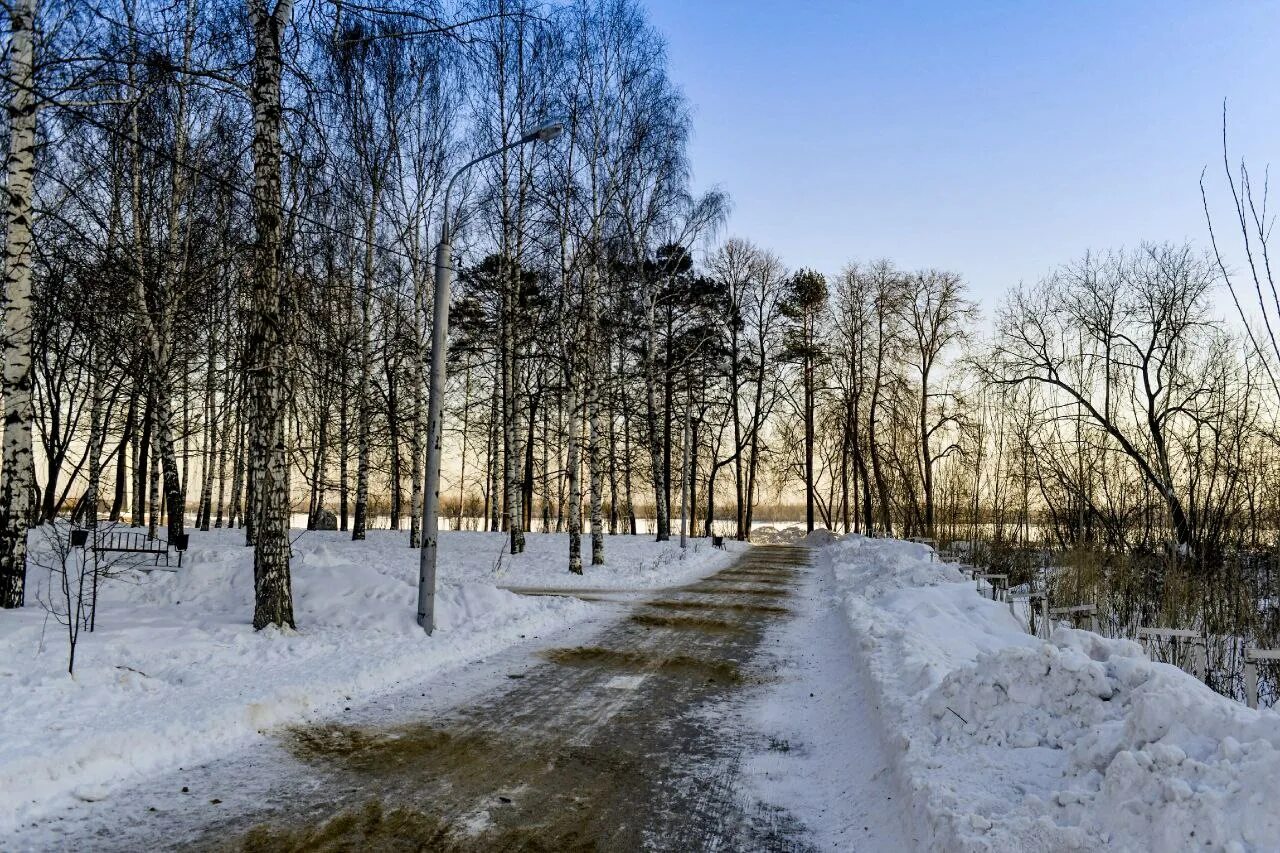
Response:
13,546,911,850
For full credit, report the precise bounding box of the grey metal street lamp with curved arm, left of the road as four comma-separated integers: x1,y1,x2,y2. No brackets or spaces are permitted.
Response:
417,119,567,634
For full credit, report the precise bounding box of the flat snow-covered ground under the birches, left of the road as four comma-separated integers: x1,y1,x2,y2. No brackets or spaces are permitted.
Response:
0,530,742,835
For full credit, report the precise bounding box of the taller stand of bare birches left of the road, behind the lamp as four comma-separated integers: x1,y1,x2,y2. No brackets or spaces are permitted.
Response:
0,0,723,626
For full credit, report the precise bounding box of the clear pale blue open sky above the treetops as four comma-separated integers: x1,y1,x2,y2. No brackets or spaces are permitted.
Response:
646,0,1280,304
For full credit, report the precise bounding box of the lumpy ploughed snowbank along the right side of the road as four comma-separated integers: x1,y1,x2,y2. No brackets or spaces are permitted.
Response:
819,535,1280,852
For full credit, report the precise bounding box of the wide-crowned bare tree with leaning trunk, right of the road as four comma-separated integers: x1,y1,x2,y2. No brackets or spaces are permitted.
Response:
987,245,1216,548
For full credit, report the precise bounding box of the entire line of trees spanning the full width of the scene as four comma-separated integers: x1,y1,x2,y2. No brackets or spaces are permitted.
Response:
0,0,1276,635
